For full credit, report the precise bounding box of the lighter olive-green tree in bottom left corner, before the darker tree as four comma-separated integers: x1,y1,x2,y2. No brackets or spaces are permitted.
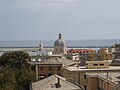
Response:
0,66,17,90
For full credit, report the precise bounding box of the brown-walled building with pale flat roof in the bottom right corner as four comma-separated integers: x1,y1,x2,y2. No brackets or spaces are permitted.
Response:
85,71,120,90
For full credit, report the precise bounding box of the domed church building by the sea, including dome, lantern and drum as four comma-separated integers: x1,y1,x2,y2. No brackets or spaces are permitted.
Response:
53,34,67,54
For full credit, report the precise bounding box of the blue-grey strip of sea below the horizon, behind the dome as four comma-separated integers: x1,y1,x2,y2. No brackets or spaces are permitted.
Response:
0,39,120,47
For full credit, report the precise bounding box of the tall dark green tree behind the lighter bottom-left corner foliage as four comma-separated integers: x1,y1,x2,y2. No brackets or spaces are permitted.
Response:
0,51,34,90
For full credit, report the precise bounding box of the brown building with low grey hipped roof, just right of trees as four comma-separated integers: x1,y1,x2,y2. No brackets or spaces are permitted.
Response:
33,59,63,80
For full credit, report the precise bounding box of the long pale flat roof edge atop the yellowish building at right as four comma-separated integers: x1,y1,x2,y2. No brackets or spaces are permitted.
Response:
65,66,120,71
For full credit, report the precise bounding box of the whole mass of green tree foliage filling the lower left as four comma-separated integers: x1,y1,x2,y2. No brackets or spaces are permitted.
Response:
0,51,34,90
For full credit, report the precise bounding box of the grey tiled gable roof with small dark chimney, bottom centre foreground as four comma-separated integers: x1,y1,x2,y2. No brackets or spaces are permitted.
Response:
32,74,82,90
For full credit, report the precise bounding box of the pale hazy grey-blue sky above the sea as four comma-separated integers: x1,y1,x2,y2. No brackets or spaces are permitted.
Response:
0,0,120,41
